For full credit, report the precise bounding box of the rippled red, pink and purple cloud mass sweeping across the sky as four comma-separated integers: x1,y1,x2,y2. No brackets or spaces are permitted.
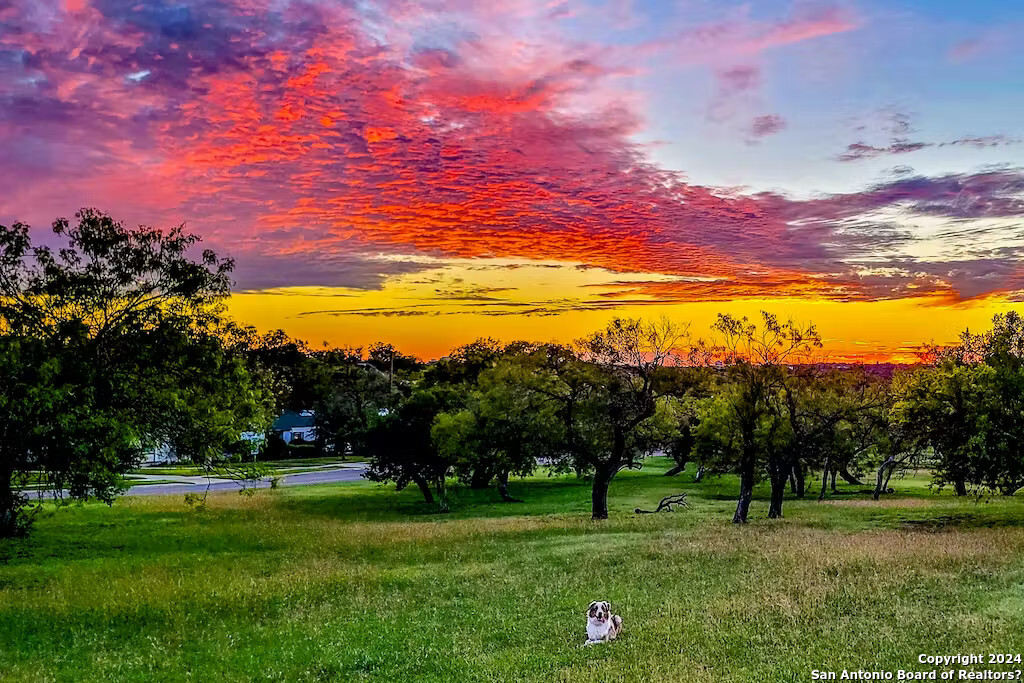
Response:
0,0,1024,299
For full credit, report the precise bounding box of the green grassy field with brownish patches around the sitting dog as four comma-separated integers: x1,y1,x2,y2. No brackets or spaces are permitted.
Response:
0,460,1024,682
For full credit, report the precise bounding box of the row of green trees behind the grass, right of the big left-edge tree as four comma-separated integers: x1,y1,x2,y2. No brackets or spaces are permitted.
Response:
258,312,1024,522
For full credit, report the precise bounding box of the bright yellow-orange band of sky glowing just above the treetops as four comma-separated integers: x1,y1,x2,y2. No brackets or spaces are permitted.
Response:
228,259,1014,362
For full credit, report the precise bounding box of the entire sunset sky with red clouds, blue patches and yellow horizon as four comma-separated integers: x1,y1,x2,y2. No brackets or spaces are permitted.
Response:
0,0,1024,360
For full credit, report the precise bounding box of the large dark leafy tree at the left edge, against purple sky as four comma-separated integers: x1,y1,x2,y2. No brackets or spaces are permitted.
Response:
0,210,269,535
